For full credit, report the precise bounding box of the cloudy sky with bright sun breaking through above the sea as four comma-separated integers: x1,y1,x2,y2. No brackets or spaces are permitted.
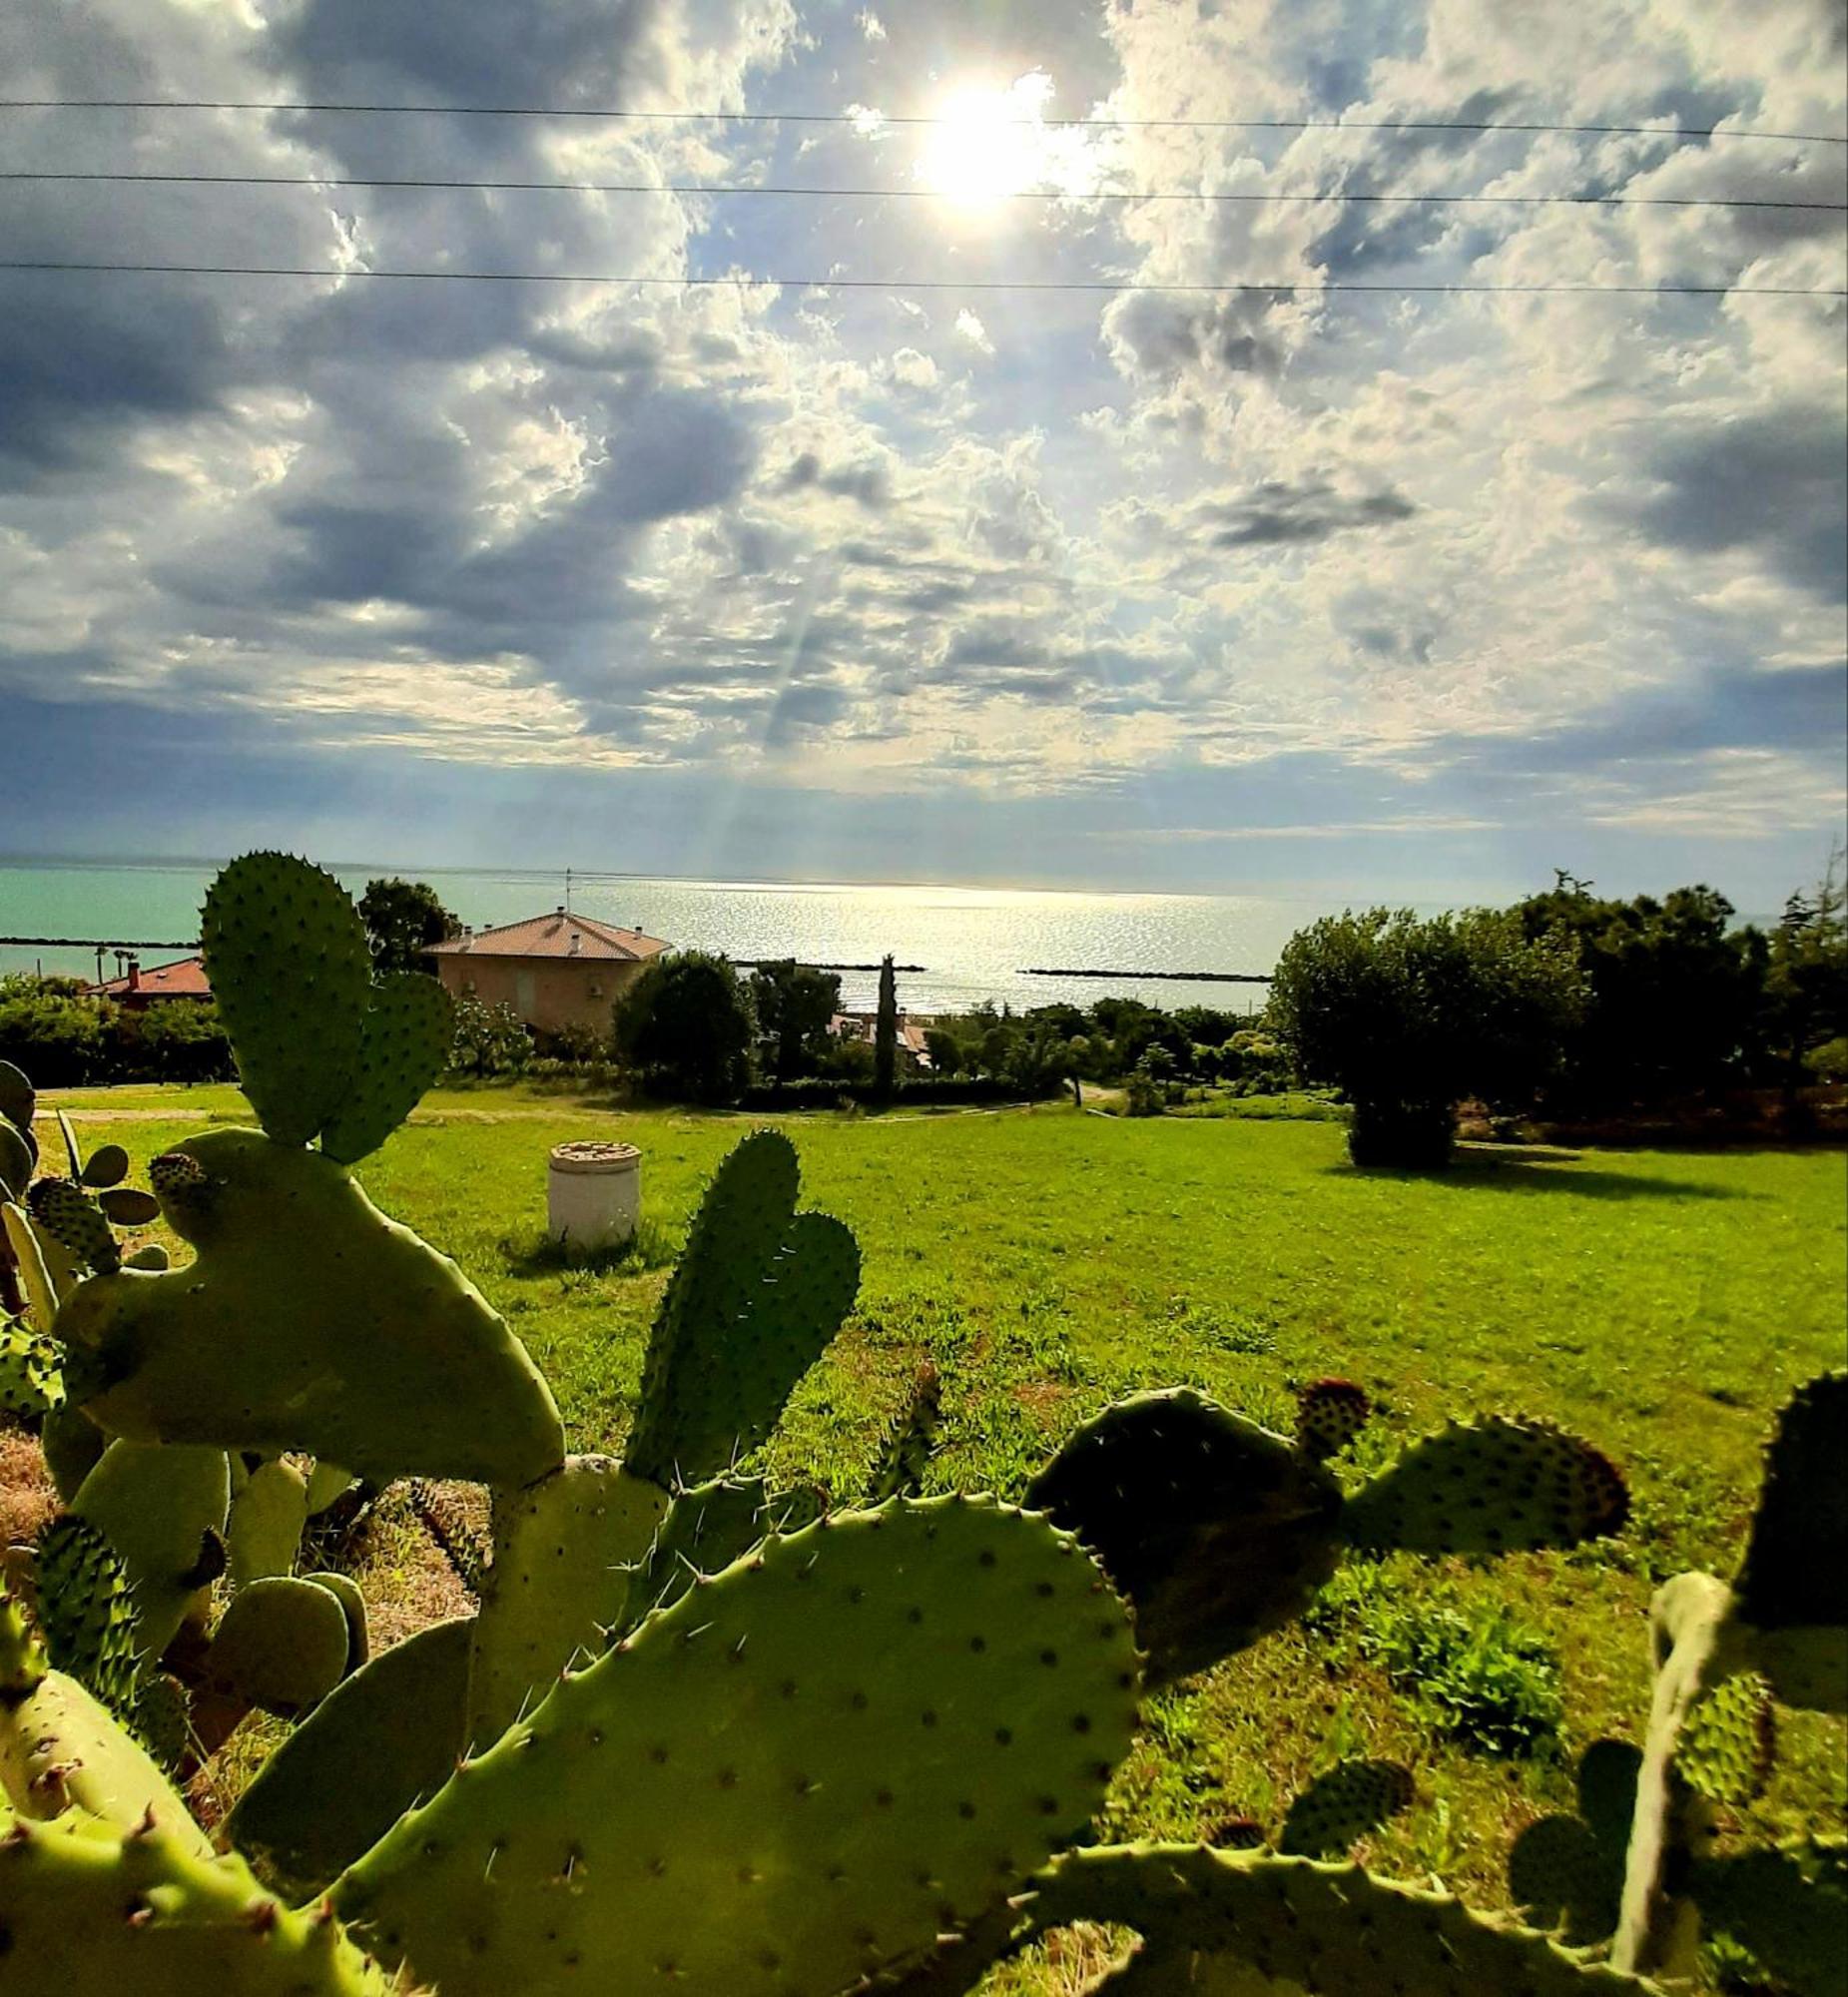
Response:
0,0,1848,911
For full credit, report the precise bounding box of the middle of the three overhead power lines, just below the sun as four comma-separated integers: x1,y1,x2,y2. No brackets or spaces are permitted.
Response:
0,170,1848,214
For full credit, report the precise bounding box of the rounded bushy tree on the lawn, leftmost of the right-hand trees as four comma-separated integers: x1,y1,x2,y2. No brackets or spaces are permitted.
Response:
1269,909,1580,1166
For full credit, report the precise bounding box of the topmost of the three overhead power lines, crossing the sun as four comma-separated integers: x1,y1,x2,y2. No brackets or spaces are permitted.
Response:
0,98,1848,146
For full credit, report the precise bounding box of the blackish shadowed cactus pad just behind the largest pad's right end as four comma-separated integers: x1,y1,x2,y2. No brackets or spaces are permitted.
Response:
1025,1388,1341,1683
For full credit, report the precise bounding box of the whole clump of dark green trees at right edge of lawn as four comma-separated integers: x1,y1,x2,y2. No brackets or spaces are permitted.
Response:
1267,865,1848,1166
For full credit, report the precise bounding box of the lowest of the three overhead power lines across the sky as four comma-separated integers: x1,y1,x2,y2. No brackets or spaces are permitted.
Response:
0,258,1848,298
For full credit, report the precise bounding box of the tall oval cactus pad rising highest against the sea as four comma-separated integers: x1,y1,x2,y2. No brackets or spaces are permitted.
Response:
200,853,371,1144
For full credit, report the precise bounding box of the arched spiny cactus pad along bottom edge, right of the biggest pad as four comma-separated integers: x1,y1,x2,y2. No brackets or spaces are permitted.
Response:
1031,1845,1646,1997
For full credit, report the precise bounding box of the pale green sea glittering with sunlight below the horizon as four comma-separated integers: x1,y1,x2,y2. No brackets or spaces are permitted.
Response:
0,861,1327,1012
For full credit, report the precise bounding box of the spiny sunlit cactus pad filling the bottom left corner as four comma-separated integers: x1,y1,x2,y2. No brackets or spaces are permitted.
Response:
0,1817,391,1997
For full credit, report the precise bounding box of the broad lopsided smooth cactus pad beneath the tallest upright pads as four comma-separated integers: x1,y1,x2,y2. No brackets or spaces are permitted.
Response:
58,1130,565,1484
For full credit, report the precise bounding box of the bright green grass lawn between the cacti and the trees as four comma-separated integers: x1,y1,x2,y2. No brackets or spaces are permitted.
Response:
18,1088,1848,1965
